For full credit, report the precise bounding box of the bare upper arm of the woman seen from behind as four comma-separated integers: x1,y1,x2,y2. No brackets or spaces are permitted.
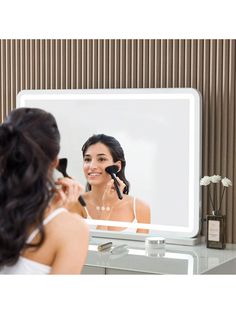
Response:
51,213,89,274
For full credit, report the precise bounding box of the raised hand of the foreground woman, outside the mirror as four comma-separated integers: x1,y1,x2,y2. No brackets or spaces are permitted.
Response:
53,178,84,212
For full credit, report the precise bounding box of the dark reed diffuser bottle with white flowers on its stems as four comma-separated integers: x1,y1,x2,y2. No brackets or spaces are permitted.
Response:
200,175,232,249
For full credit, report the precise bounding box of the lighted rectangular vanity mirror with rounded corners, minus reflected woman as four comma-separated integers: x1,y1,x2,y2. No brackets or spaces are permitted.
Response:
17,88,201,238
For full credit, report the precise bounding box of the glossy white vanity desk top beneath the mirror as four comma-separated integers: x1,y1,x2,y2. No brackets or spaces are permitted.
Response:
82,238,236,275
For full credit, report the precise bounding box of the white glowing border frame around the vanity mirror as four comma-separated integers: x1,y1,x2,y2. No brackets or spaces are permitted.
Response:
17,88,201,238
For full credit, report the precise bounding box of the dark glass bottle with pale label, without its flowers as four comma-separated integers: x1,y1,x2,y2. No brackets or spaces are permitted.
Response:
206,212,226,249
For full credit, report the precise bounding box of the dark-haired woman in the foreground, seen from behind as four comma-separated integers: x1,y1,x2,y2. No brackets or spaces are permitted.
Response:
0,108,88,274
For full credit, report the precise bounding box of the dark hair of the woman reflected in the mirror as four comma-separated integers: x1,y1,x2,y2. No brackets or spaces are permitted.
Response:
82,134,130,194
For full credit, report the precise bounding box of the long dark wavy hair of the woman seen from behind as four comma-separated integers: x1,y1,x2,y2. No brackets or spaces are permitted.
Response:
0,108,60,267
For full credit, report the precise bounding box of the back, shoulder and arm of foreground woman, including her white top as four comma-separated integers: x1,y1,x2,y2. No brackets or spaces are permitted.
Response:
0,208,88,275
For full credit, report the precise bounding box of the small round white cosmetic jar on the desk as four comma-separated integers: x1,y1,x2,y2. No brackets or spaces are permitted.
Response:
145,237,166,257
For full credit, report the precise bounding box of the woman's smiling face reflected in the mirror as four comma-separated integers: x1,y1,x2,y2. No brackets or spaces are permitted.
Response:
83,143,121,186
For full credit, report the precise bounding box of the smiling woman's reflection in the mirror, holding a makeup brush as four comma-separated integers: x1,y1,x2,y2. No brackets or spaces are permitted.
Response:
77,134,150,233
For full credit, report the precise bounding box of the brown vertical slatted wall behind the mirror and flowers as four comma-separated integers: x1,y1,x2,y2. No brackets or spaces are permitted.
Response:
0,39,236,243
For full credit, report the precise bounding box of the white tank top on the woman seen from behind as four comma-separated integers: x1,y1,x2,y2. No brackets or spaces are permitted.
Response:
0,207,67,275
